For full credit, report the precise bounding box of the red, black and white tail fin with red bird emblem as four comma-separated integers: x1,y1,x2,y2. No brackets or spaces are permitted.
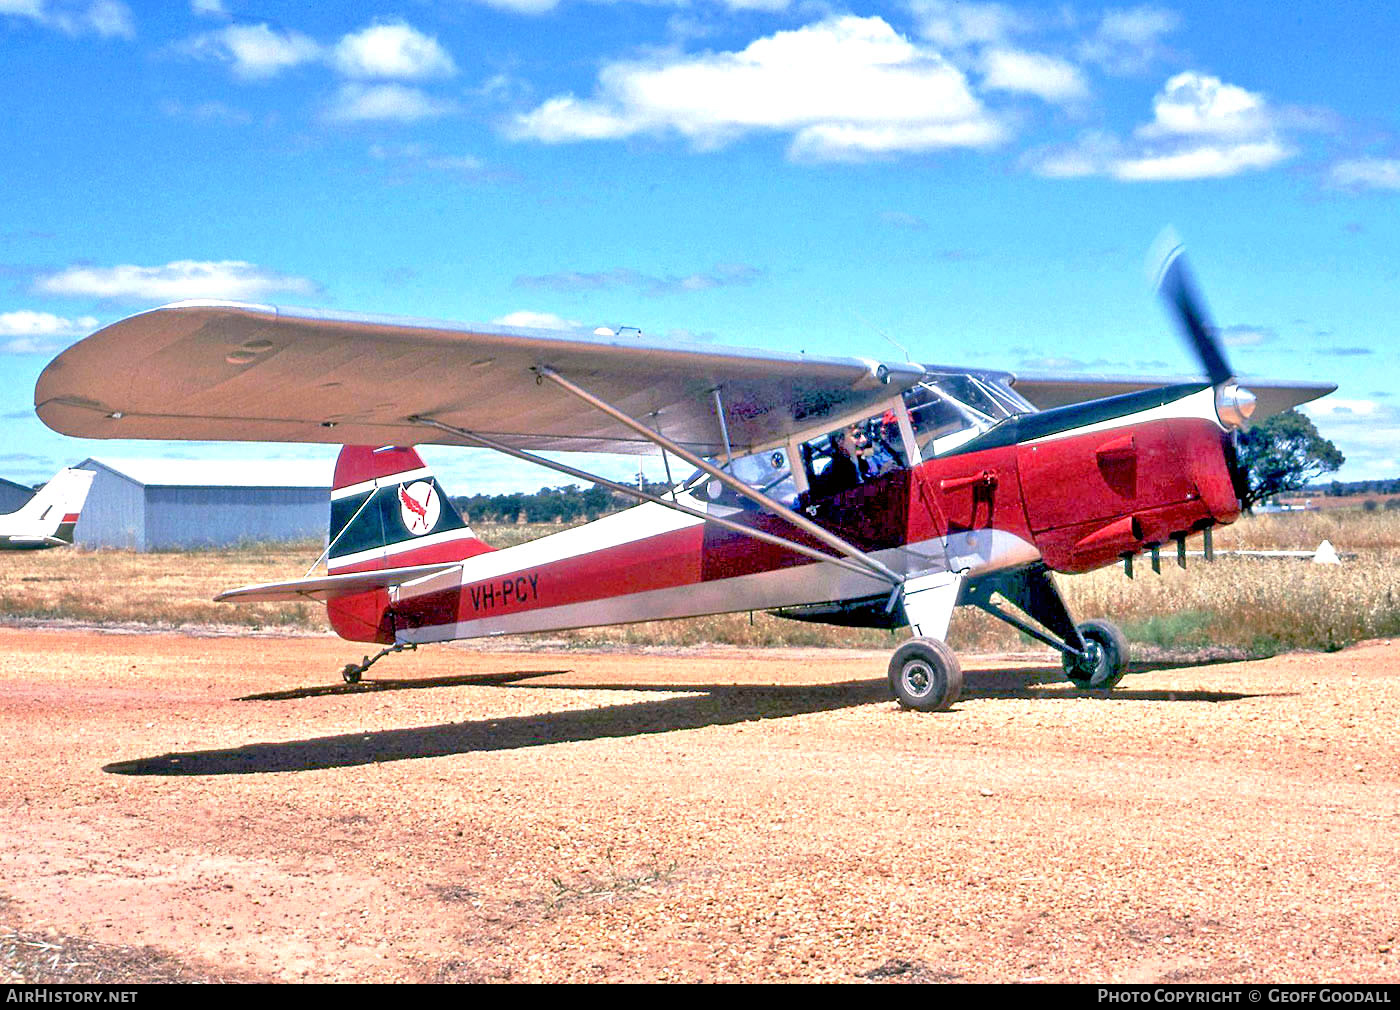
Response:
326,445,491,574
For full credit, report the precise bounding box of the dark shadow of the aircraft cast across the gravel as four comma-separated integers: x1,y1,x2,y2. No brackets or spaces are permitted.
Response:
102,667,1276,776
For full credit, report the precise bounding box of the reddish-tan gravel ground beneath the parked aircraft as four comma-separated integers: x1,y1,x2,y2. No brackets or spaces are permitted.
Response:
0,628,1400,982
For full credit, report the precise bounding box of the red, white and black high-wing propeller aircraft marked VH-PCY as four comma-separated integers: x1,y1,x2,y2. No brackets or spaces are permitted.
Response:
35,249,1336,710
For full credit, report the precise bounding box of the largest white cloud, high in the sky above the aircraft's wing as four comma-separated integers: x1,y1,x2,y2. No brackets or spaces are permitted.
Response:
511,17,1005,160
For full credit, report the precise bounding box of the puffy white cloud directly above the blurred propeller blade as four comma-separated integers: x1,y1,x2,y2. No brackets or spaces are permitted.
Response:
1025,71,1294,182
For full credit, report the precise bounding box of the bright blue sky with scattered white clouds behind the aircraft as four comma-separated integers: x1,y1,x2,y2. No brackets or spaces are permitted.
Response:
0,0,1400,493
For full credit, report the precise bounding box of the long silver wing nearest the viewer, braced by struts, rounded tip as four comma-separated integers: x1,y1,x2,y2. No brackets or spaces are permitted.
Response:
34,301,924,455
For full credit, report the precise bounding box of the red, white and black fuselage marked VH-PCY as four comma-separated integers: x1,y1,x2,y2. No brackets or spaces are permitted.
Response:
330,384,1239,643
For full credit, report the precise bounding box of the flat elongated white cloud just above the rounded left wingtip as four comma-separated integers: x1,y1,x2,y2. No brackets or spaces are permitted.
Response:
34,259,318,301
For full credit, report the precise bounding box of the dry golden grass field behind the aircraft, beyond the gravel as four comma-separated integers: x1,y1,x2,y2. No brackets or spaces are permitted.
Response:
0,510,1400,657
